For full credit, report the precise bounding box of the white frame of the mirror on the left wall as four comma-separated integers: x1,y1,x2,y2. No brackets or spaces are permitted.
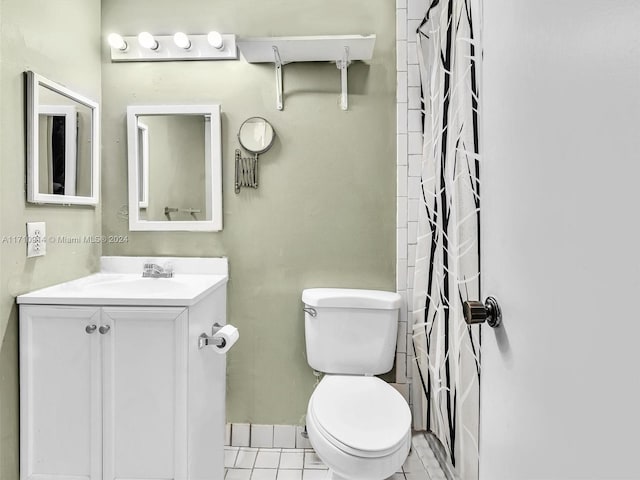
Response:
26,71,100,205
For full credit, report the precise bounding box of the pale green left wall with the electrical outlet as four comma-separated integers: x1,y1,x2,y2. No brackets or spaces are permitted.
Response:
0,0,101,480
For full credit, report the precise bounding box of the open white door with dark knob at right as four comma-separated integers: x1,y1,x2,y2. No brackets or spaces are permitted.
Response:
480,0,640,480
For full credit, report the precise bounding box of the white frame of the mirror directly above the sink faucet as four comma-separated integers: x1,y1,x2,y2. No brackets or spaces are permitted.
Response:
127,104,222,232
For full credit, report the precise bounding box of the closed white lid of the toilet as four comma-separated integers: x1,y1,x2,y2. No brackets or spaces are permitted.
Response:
309,375,411,455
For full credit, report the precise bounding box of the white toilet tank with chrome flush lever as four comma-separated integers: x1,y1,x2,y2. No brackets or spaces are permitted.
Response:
302,288,402,375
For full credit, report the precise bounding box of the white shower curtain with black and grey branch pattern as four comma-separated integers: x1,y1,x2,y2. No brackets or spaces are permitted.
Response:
412,0,482,480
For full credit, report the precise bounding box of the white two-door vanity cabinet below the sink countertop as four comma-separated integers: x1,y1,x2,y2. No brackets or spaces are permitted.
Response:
18,256,226,480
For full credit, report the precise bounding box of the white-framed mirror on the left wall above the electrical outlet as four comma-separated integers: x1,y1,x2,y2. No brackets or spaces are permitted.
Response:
26,71,100,205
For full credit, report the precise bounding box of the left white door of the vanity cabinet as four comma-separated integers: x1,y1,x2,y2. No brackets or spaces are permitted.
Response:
20,305,102,480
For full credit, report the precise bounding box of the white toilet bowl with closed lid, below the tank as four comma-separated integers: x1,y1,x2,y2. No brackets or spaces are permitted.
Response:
307,375,411,480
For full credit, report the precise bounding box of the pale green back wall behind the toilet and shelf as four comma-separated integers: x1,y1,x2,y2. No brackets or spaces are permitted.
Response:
102,0,396,424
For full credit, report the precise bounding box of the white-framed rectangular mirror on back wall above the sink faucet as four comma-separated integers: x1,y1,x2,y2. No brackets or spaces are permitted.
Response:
127,105,222,231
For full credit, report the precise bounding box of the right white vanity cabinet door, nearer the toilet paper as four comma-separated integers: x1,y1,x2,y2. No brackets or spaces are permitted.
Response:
100,307,188,480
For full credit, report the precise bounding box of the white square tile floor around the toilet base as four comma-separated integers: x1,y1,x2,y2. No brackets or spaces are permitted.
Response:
224,434,446,480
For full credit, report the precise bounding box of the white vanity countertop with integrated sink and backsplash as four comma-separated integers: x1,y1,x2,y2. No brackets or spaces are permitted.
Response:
17,257,228,306
